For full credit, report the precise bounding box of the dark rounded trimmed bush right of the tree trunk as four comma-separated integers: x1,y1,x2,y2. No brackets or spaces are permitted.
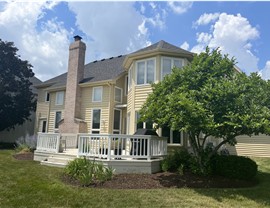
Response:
212,155,258,180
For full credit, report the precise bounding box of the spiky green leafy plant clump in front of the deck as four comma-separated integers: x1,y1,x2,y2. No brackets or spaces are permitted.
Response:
65,157,114,186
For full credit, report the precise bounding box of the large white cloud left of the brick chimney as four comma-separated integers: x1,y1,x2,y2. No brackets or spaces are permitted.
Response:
0,2,70,80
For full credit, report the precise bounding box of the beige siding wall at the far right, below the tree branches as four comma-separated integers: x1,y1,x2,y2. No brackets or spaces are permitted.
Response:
226,134,270,157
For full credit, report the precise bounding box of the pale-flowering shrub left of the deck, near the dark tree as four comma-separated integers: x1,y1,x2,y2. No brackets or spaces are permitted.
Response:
15,134,37,152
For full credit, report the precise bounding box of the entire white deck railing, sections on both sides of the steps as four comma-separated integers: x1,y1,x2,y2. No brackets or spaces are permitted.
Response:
37,133,167,160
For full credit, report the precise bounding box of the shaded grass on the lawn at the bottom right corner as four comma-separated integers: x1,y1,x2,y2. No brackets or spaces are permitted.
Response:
194,171,270,207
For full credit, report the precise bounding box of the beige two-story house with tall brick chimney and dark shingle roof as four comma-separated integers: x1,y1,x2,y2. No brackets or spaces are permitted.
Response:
35,36,196,172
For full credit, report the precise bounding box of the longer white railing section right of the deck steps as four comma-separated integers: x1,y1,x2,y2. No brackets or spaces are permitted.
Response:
78,134,167,160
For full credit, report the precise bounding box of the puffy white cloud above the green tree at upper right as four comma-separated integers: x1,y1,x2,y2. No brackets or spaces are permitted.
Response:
192,13,259,74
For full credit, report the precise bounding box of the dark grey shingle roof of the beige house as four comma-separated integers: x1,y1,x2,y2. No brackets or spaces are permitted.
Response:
36,40,193,89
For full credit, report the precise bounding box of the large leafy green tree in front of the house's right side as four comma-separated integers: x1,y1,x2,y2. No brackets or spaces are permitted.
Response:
140,48,270,173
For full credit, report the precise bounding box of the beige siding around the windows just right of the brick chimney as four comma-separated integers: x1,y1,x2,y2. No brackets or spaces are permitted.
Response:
81,85,111,134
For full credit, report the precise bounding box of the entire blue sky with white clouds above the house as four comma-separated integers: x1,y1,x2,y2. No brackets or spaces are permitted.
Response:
0,1,270,81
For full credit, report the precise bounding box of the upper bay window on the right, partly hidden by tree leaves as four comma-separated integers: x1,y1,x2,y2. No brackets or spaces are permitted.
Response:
161,57,183,80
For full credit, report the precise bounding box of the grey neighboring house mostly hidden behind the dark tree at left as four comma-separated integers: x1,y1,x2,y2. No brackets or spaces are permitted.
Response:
0,77,42,143
